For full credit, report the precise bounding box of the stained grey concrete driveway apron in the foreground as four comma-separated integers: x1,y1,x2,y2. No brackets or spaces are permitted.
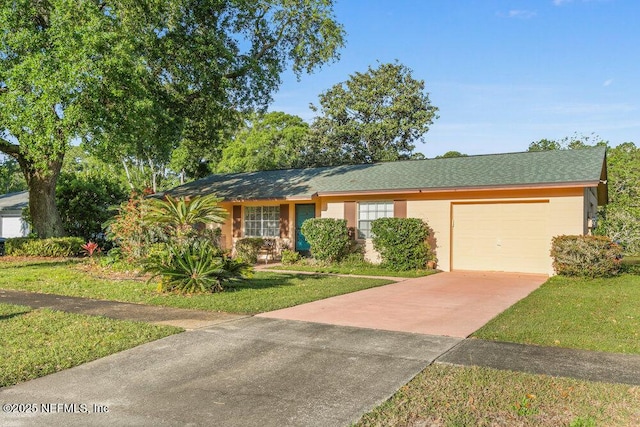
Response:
0,317,460,427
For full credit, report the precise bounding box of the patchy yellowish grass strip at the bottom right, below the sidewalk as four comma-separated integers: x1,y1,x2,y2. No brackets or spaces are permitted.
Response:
356,365,640,427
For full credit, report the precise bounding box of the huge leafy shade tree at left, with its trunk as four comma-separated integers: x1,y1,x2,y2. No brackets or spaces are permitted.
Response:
0,0,343,237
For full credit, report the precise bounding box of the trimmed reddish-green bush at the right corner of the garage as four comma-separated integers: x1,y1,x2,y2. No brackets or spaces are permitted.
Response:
551,236,622,277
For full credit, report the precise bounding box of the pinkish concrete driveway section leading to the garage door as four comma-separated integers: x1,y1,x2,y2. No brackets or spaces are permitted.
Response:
259,272,548,338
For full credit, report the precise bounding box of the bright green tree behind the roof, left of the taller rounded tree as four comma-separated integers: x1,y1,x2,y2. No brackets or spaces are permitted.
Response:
216,112,309,173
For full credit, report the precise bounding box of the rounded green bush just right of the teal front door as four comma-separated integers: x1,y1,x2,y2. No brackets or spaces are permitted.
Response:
302,218,350,262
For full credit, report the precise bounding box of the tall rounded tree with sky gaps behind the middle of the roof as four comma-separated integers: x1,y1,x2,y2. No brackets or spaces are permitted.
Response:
311,63,438,165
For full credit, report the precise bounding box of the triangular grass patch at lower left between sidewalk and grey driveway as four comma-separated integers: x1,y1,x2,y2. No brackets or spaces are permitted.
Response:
0,304,182,387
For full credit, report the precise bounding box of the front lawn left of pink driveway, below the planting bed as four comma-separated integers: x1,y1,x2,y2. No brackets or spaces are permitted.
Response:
0,258,390,314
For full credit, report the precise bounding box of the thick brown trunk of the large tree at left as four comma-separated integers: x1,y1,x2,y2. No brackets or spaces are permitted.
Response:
19,158,65,239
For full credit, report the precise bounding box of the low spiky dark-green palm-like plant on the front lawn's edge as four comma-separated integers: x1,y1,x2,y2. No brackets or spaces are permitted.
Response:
143,240,250,293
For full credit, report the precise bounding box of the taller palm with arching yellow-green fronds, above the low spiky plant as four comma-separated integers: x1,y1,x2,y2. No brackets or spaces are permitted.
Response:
146,194,229,241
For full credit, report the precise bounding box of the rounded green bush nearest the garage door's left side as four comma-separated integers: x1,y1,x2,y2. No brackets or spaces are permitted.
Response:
371,218,429,271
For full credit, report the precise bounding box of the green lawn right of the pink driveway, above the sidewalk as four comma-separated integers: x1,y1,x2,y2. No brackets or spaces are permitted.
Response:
473,274,640,354
